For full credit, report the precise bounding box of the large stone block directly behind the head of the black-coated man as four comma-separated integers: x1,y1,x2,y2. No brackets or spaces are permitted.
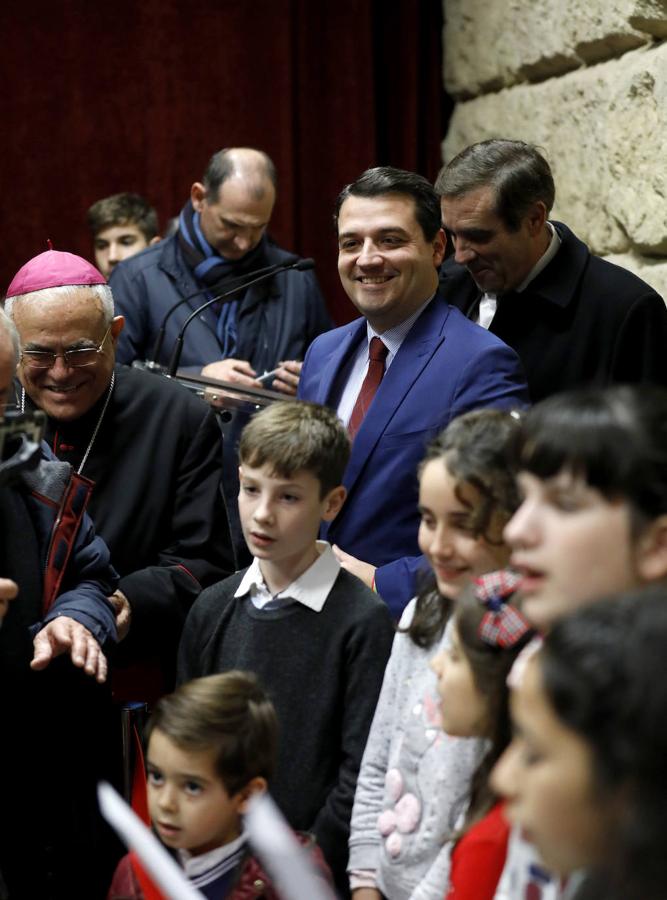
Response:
443,44,667,256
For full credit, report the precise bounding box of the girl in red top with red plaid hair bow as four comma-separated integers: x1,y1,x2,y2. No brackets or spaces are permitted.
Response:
431,572,534,900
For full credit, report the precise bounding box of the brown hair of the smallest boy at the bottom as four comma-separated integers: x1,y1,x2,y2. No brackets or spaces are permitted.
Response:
146,670,278,797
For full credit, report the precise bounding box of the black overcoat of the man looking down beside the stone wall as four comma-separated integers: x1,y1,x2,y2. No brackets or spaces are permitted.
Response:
440,222,667,403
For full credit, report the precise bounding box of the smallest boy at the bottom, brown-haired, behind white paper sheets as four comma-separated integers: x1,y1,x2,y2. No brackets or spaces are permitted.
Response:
109,672,332,900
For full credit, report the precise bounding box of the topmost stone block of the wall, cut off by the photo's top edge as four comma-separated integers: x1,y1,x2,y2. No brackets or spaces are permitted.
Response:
444,0,656,99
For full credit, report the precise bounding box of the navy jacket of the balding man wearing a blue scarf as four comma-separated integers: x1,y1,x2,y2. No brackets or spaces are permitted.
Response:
109,235,331,373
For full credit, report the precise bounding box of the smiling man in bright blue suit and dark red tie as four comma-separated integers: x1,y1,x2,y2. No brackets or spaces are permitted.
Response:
299,166,528,617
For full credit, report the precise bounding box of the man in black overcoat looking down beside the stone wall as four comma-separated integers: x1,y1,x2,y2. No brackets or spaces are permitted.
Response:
435,140,667,402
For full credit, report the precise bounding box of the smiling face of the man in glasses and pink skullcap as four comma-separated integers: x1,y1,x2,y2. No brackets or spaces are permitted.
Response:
13,287,123,421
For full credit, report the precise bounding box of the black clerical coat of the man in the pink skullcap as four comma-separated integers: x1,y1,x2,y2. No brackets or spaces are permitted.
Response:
26,366,235,684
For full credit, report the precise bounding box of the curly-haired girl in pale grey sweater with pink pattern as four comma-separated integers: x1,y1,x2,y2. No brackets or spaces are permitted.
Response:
348,410,518,900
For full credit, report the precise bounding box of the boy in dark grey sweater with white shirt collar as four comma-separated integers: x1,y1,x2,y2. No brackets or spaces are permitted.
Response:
179,402,394,893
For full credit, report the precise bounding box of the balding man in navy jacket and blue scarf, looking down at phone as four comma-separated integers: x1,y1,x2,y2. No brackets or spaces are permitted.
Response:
109,147,331,394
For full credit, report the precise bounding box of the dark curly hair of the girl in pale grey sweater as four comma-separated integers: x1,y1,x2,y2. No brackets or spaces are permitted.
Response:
408,409,519,648
